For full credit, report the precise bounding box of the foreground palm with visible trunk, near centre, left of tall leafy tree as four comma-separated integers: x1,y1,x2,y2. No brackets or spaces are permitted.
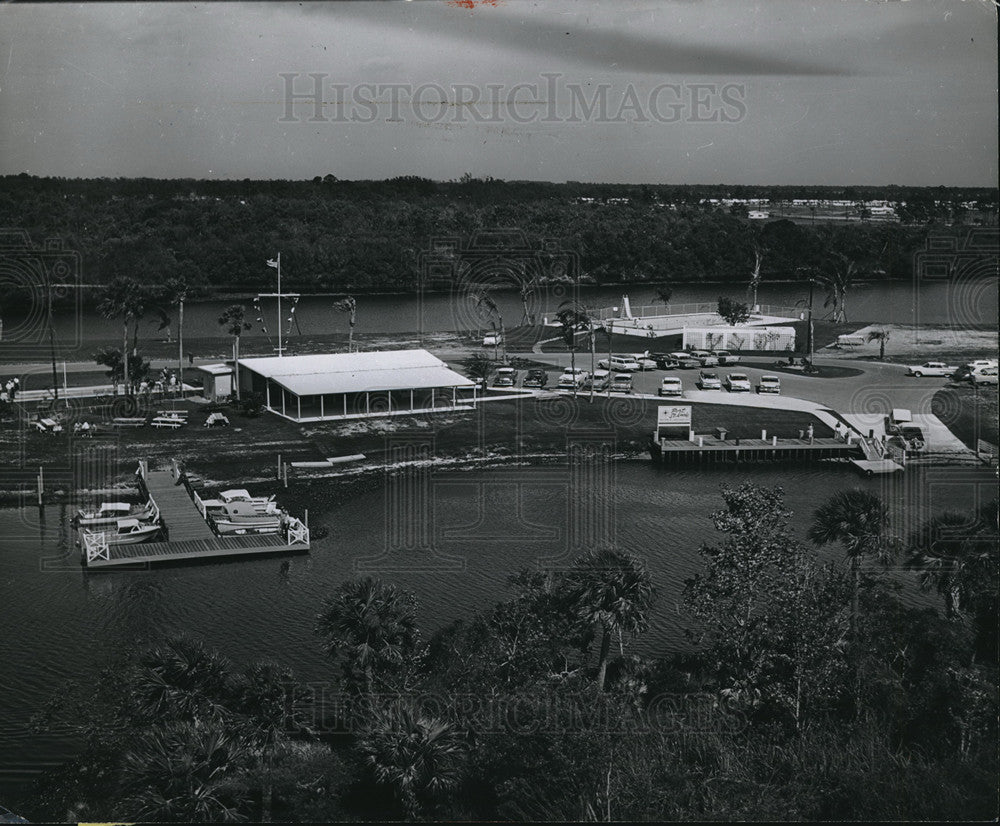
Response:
565,549,655,691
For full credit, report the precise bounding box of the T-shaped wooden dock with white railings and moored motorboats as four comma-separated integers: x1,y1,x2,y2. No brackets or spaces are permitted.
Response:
83,462,310,568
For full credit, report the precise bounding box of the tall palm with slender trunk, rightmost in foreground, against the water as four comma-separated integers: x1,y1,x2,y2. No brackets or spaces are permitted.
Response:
808,488,895,639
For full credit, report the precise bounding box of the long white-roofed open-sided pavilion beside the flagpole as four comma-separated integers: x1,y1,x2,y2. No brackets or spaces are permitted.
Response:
239,350,476,422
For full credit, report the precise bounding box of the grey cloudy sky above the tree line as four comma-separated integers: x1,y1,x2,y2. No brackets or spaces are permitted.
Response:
0,0,997,186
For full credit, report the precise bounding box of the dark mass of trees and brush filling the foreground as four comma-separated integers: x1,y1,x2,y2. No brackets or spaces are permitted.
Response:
22,483,1000,822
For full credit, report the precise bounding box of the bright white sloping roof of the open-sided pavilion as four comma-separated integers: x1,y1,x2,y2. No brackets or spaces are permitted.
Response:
240,350,474,396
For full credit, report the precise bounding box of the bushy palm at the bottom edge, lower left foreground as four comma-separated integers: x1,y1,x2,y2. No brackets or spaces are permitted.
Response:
121,721,250,823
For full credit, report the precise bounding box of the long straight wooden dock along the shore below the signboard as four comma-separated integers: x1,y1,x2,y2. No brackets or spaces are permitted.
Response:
649,435,861,465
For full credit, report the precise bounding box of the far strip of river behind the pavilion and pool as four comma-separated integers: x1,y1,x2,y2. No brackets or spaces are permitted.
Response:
35,279,997,344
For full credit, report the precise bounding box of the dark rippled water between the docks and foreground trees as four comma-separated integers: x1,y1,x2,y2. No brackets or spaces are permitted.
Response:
0,462,995,795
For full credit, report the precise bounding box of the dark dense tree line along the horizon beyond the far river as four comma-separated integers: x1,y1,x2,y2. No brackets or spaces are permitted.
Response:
0,175,996,293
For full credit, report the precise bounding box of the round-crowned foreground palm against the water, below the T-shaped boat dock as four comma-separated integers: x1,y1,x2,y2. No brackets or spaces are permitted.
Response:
315,577,419,695
